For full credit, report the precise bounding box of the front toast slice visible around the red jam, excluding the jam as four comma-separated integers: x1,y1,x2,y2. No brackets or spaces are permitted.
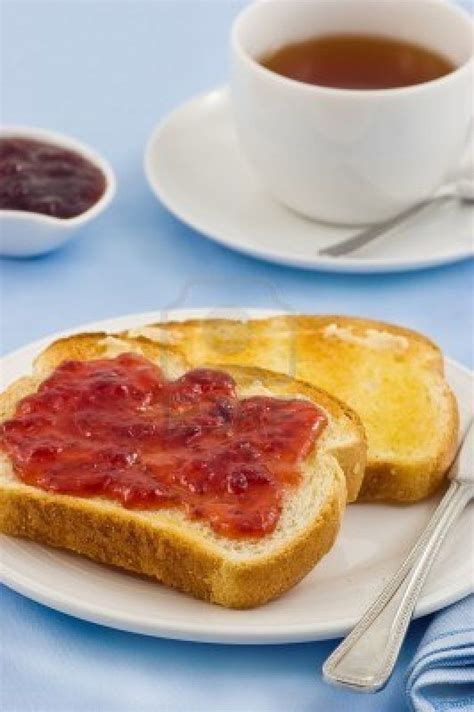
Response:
0,334,366,608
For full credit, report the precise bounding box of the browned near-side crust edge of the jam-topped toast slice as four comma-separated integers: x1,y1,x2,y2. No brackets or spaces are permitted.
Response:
0,470,346,608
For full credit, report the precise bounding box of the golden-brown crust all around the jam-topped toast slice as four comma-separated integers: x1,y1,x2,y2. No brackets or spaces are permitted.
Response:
0,333,360,608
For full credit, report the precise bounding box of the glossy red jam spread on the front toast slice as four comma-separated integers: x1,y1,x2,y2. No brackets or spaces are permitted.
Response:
0,353,326,537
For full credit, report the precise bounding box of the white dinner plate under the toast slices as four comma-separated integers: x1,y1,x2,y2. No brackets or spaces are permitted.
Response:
0,310,473,643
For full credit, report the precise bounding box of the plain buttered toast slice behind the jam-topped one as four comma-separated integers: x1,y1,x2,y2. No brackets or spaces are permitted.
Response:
134,315,459,502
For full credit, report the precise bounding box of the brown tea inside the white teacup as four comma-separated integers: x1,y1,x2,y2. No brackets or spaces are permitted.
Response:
260,35,455,89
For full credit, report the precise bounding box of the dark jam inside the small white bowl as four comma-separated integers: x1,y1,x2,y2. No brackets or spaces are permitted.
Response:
0,137,106,218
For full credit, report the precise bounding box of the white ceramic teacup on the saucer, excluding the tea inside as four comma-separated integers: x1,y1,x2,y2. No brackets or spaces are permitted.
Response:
232,0,474,224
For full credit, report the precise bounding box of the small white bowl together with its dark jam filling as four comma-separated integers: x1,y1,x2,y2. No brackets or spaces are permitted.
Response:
0,127,115,257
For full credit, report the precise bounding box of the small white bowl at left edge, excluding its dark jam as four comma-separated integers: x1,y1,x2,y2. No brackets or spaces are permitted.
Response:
0,126,116,257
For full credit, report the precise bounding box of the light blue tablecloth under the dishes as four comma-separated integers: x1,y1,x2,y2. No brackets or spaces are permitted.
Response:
0,0,474,712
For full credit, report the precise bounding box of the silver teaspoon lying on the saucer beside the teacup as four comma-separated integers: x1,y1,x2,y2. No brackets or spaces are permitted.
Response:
319,178,474,257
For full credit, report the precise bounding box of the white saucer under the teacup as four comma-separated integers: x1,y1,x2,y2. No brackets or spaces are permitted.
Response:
145,88,474,272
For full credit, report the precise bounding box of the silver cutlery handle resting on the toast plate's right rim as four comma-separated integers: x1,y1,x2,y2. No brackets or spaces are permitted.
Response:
323,422,474,692
